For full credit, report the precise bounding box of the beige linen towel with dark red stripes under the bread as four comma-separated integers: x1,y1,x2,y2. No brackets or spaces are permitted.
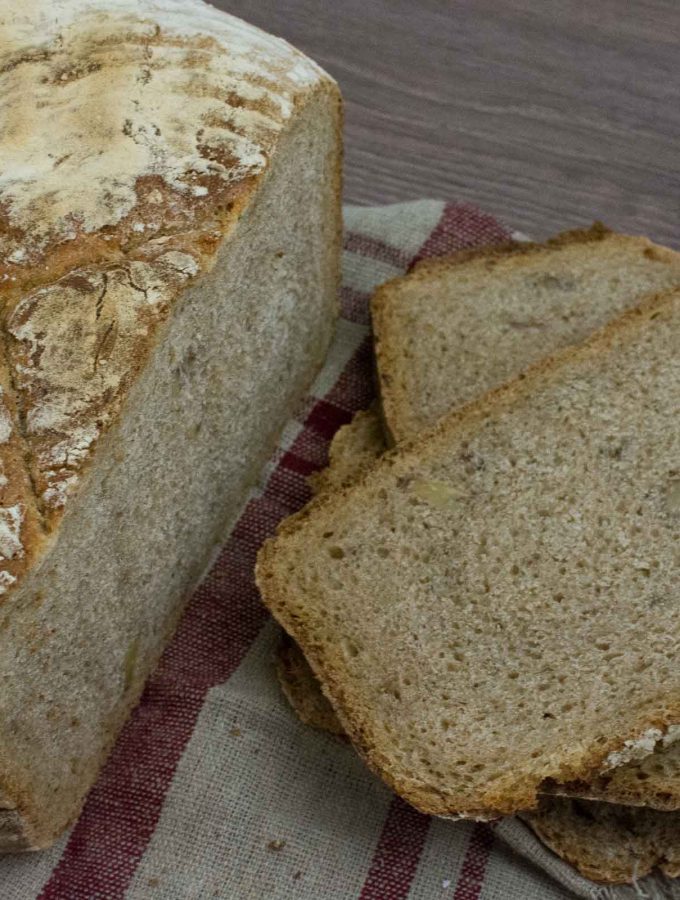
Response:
0,201,680,900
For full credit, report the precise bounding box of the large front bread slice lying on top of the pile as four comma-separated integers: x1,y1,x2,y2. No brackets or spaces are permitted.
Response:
258,293,680,815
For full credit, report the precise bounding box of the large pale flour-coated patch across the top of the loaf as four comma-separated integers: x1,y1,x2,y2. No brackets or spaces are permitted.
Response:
0,0,320,268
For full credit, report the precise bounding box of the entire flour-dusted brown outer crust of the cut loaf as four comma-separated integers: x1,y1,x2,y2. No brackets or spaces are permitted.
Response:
0,0,329,556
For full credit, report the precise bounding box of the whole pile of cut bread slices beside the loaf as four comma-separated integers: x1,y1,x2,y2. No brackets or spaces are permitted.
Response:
257,225,680,882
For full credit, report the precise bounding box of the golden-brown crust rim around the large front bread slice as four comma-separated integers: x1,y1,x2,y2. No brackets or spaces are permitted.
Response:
256,291,680,817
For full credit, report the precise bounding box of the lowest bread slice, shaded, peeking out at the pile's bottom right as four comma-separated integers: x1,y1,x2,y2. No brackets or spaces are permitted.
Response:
521,798,680,884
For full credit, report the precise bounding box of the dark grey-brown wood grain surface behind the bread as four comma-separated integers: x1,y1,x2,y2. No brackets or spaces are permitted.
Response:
213,0,680,247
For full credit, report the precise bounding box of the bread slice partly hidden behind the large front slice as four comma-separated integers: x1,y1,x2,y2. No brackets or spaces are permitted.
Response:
372,224,680,443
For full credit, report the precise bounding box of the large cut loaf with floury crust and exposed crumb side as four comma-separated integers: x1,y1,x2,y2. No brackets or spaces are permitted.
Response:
0,0,341,850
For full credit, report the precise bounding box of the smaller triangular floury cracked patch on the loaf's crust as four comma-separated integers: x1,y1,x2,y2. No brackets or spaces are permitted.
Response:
6,239,199,521
